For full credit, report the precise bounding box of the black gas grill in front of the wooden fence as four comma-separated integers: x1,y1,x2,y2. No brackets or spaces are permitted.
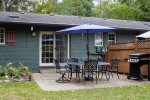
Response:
128,53,150,81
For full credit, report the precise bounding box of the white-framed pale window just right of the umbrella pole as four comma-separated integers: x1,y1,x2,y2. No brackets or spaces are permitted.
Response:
95,33,103,46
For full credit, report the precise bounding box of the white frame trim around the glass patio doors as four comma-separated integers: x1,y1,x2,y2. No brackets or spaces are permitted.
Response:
39,31,70,67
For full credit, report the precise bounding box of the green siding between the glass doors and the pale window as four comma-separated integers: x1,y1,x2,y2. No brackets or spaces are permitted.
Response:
70,34,98,60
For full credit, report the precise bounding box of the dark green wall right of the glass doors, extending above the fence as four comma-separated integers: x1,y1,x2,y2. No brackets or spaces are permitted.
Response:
70,30,137,59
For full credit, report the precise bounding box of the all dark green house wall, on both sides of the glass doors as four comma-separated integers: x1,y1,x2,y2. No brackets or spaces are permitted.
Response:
0,24,144,72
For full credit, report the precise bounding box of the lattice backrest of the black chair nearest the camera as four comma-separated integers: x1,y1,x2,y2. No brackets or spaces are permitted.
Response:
84,60,98,71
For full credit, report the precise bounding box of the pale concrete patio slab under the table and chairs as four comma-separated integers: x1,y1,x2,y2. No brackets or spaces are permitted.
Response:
33,73,150,91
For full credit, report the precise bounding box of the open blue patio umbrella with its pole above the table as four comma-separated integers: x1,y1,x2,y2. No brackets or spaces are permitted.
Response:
57,24,115,59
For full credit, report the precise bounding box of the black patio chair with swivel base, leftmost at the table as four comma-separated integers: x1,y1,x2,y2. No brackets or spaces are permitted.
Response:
54,59,70,83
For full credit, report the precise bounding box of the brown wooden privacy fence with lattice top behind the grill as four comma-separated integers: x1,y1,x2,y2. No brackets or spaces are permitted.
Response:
106,40,150,75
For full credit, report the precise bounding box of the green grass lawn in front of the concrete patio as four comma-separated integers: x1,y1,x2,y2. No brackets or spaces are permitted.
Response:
0,82,150,100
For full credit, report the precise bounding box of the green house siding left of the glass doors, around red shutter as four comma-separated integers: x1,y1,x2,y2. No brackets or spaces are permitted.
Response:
0,30,39,72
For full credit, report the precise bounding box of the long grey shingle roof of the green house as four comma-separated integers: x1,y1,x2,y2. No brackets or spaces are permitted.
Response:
0,12,150,30
